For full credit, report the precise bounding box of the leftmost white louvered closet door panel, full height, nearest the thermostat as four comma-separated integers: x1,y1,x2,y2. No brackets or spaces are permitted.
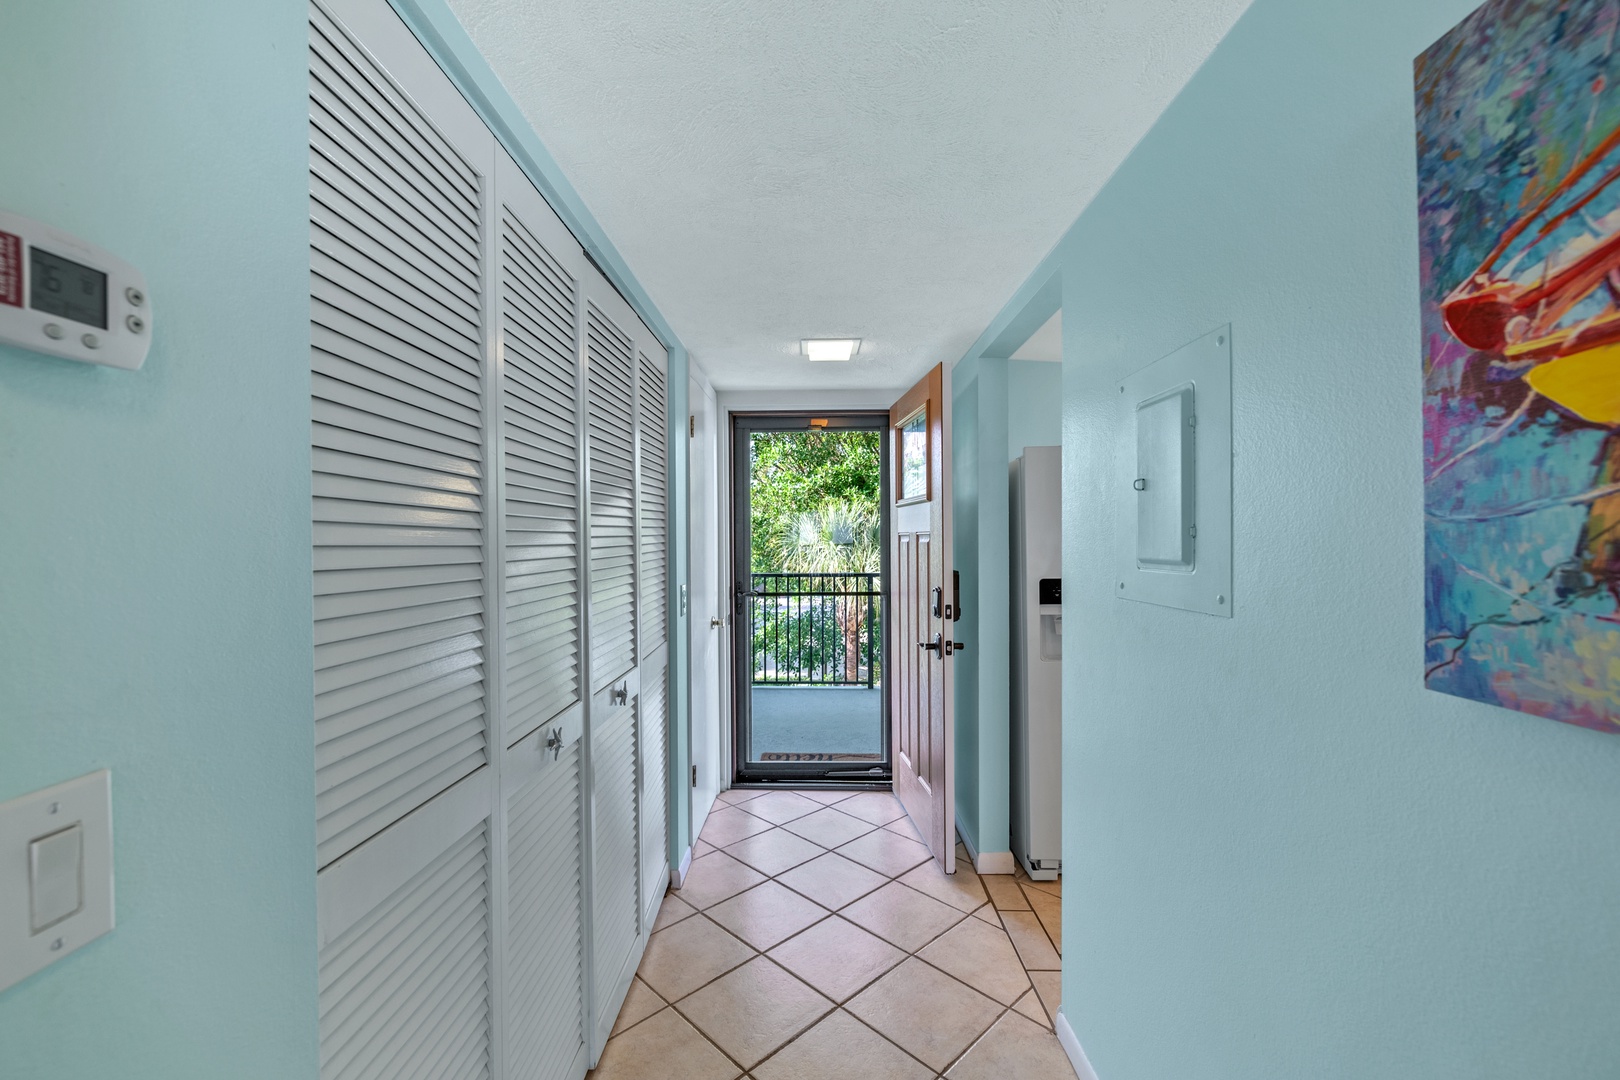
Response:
309,0,504,1080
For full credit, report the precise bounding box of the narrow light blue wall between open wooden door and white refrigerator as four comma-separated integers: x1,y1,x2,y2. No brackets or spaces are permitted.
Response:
951,356,1061,852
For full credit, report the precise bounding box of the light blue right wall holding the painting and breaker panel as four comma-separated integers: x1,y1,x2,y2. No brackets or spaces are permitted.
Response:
982,0,1620,1080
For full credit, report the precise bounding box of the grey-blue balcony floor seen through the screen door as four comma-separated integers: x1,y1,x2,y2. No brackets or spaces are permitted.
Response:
753,687,883,761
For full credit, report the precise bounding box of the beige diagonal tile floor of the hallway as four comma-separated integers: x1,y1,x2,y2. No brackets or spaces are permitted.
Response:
591,790,1074,1080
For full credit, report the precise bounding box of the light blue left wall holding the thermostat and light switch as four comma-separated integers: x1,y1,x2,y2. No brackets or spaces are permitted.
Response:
0,0,318,1080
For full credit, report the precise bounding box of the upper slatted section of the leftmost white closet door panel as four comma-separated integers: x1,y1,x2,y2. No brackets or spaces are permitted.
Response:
309,0,489,867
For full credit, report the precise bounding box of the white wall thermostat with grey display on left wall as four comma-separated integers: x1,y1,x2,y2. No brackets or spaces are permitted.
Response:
0,210,152,371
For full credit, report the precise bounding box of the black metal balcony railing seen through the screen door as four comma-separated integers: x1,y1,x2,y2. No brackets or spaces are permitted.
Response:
748,573,883,687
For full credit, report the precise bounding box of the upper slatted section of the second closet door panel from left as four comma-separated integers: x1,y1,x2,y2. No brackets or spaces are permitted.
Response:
501,207,580,745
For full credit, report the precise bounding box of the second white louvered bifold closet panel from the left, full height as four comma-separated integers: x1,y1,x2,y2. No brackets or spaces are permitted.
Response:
496,151,596,1080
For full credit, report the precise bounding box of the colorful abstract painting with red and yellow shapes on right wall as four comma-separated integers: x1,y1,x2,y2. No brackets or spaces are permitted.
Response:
1416,0,1620,732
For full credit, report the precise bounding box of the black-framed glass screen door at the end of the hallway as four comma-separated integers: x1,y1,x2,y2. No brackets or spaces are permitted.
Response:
732,413,891,782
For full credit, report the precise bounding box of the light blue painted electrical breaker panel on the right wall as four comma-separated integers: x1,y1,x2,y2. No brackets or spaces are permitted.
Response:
1113,325,1233,617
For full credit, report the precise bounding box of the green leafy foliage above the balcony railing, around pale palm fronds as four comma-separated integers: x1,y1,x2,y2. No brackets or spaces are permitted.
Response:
748,431,881,573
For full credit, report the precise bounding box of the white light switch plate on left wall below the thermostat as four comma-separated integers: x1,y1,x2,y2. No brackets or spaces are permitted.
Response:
0,769,113,991
